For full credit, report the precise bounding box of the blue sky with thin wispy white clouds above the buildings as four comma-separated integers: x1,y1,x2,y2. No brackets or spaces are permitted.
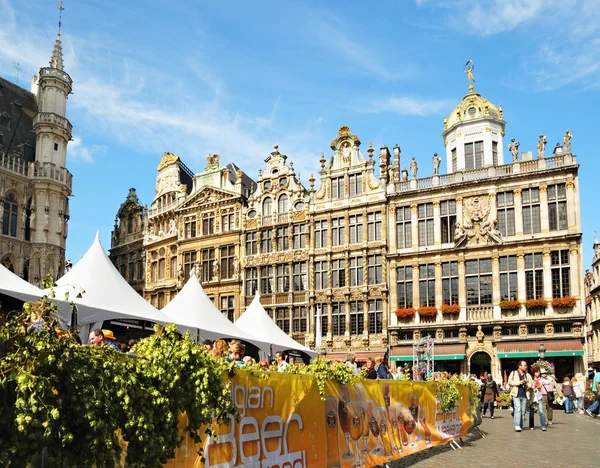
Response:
0,0,600,267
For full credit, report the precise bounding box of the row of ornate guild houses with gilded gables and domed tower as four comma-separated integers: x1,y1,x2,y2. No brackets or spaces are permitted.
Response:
111,74,584,379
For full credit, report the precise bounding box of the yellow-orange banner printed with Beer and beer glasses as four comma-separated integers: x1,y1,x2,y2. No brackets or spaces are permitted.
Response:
165,371,471,468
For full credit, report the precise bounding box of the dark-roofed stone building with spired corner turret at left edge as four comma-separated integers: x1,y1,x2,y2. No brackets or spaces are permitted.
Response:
0,32,73,286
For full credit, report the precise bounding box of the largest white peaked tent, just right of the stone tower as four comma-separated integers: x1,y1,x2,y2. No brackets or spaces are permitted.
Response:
49,234,171,330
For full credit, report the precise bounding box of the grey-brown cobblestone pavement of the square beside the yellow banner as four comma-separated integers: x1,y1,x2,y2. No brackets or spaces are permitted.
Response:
389,409,600,468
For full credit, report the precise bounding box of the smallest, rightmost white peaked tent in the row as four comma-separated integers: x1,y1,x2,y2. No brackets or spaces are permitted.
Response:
235,292,317,357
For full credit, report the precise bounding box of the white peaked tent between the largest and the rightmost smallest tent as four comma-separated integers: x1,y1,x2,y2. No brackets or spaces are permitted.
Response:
161,270,270,354
